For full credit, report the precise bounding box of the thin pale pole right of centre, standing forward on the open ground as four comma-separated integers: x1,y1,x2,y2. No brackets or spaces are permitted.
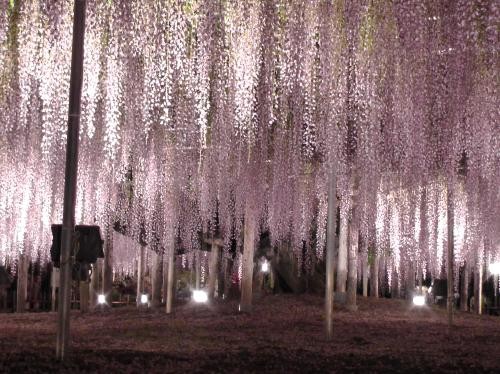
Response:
325,168,337,339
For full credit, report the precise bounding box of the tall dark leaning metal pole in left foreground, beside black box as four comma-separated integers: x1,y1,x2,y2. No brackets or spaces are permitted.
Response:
56,0,87,360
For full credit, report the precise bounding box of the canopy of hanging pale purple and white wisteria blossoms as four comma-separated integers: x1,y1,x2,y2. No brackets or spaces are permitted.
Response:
0,0,500,286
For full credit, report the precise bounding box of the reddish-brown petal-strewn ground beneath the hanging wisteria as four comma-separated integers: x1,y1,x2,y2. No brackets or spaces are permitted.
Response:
0,295,500,373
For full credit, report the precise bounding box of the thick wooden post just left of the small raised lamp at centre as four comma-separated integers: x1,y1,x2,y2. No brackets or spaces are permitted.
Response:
240,202,255,312
